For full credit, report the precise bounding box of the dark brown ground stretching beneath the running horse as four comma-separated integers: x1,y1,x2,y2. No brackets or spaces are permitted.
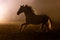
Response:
0,24,60,40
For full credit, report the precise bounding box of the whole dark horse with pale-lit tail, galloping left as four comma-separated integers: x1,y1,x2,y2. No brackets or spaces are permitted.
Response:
17,5,52,30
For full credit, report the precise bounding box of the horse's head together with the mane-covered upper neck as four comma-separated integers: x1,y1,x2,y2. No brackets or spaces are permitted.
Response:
17,5,34,15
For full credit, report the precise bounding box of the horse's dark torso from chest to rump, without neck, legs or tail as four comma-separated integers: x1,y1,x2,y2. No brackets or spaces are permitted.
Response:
26,15,49,25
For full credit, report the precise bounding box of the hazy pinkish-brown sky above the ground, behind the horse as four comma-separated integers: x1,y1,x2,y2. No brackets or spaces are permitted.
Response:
0,0,60,23
